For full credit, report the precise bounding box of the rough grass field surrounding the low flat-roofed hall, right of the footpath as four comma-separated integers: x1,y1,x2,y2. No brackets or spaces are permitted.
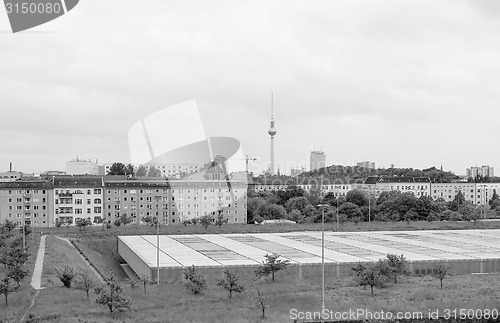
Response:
14,222,500,322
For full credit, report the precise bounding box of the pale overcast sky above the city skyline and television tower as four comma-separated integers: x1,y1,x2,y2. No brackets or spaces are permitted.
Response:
0,0,500,175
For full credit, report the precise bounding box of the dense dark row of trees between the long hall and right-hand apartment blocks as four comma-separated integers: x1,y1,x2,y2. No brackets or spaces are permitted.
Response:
247,186,500,224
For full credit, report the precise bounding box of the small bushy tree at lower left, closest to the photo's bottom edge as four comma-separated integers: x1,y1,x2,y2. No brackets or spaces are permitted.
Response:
94,272,132,317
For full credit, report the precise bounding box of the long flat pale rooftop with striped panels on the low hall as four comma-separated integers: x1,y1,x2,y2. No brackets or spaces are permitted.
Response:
118,230,500,268
